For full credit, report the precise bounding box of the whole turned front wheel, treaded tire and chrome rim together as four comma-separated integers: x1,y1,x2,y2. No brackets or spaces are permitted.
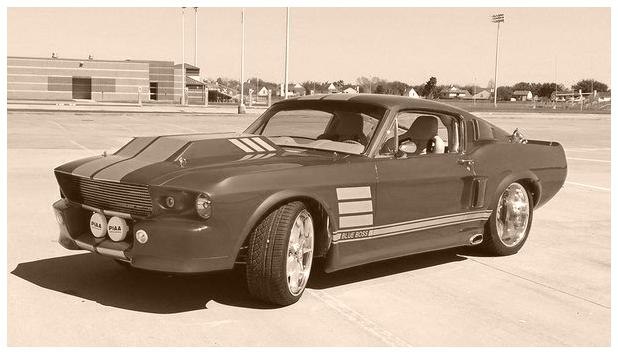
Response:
246,202,315,305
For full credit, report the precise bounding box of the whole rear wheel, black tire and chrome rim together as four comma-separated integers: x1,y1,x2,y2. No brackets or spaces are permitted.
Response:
483,182,533,256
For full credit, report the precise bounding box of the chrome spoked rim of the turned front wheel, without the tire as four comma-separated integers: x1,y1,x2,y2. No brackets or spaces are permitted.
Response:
286,210,314,296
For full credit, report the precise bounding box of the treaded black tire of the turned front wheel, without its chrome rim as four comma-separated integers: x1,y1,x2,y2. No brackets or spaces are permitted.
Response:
246,202,307,306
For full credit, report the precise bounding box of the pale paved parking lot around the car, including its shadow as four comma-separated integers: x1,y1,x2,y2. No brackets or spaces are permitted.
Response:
7,112,611,346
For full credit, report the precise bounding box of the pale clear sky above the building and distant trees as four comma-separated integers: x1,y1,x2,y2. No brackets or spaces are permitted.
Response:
7,7,611,86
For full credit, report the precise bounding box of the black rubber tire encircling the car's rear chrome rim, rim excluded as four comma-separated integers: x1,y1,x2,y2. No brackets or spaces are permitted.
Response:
481,182,534,256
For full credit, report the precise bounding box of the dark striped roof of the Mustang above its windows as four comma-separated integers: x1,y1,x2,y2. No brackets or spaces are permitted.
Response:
274,93,471,117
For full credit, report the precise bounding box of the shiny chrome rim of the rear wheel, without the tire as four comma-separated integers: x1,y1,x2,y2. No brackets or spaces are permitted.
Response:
496,183,530,247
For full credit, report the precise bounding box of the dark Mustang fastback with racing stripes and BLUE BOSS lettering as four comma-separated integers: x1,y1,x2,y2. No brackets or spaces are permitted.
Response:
53,94,567,305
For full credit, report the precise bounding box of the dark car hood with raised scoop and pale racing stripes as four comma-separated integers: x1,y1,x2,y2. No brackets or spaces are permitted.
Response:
56,134,340,187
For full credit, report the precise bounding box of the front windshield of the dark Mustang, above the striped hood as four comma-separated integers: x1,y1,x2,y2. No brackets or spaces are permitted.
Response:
246,103,385,154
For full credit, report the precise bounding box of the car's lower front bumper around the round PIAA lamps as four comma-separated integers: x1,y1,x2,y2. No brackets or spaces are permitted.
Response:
53,199,235,273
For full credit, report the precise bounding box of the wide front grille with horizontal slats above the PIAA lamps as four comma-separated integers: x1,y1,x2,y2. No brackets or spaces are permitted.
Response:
57,173,152,216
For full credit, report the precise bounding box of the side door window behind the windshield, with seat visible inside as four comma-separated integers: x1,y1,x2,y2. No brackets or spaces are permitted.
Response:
380,111,459,156
